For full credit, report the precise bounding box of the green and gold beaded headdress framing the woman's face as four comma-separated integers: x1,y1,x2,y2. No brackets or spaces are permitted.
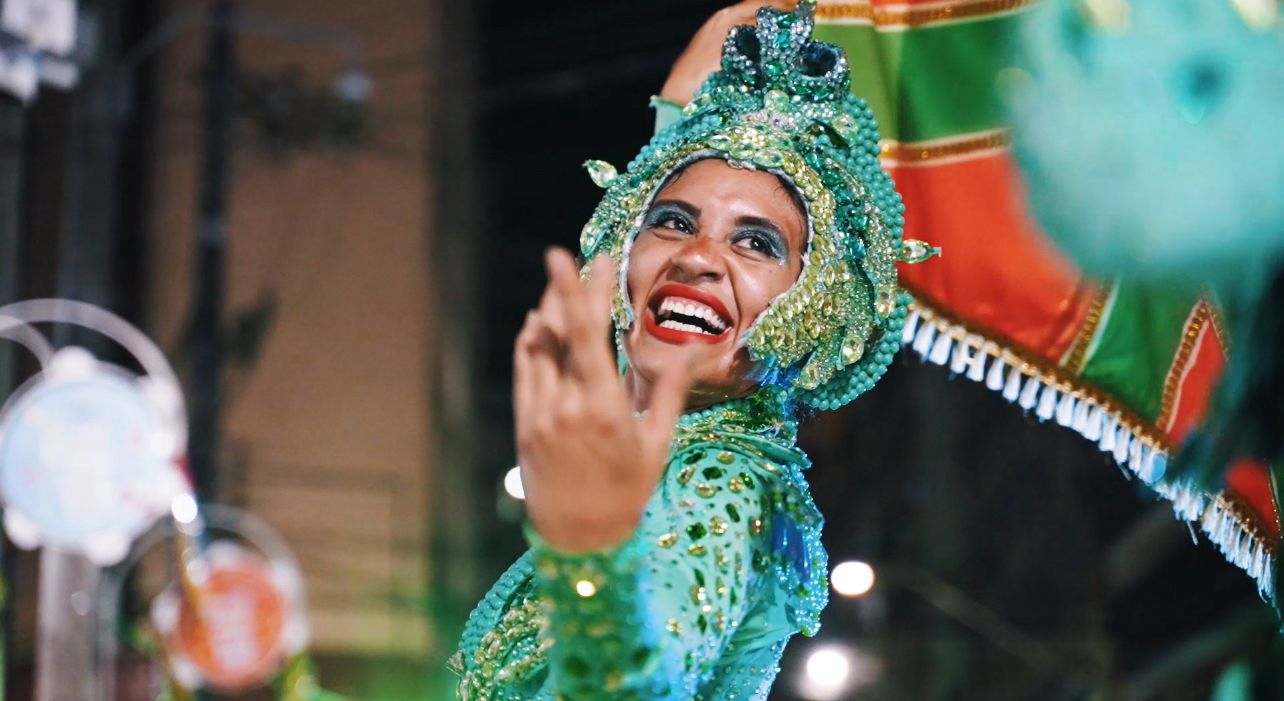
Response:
579,1,933,408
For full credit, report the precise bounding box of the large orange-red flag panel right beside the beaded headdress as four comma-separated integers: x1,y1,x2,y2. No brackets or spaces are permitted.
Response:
891,153,1091,365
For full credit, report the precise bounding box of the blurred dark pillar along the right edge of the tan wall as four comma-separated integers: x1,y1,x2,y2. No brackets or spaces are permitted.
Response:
426,3,487,693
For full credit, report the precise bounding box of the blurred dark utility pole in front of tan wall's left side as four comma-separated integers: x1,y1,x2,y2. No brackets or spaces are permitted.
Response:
189,0,238,502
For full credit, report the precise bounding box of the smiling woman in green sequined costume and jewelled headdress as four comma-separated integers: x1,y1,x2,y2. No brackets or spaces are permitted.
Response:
452,3,924,700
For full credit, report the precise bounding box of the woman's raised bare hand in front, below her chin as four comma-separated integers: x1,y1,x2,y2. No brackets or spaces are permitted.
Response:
512,249,688,552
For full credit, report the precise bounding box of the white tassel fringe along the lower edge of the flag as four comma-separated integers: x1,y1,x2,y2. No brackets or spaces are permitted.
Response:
901,303,1275,601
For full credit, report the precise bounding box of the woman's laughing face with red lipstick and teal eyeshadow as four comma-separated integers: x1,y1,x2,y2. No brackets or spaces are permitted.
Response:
625,158,806,408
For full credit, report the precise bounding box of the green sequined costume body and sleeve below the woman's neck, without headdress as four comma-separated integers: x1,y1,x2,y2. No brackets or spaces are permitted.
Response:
455,390,827,701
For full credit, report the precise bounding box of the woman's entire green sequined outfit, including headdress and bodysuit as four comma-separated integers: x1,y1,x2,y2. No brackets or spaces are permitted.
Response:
452,0,932,701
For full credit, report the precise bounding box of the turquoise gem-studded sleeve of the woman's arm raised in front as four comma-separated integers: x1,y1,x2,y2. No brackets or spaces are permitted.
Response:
528,443,799,701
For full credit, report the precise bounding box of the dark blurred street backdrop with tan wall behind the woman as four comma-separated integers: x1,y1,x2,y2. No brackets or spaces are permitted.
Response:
0,0,1284,701
